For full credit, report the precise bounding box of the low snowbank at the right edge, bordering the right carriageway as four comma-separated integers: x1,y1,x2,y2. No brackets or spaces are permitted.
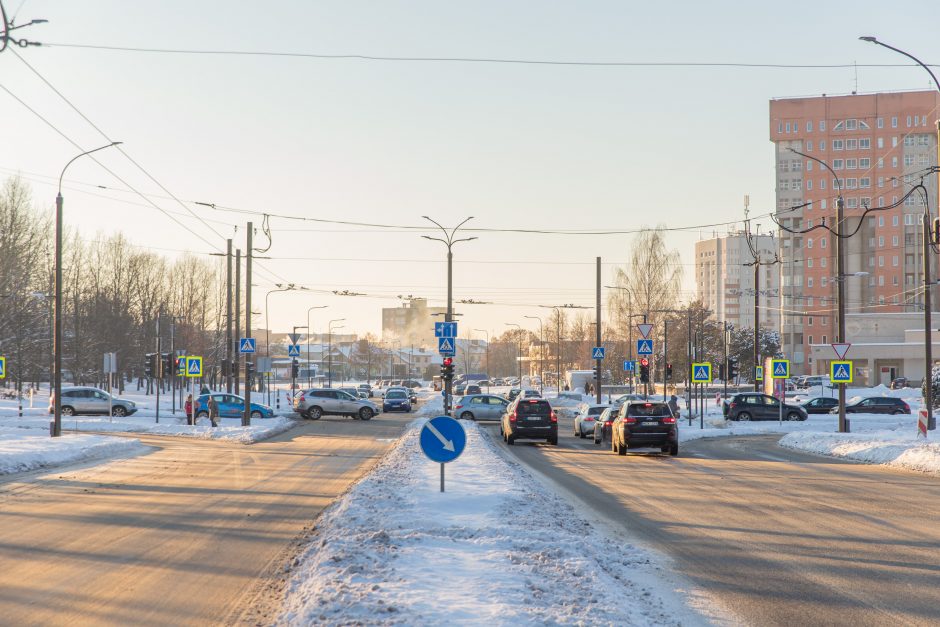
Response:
779,431,940,473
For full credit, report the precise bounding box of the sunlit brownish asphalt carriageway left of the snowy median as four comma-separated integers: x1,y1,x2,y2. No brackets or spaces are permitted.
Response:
0,414,414,626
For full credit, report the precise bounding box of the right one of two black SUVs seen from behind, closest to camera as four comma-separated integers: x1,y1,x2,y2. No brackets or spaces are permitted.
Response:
610,401,679,456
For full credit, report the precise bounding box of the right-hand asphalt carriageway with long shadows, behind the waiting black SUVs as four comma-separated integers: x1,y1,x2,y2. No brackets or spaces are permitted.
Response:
490,421,940,627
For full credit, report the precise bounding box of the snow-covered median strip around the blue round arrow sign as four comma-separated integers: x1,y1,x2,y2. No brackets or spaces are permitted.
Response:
277,400,707,625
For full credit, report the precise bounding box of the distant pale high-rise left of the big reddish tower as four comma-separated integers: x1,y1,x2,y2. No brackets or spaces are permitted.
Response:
695,232,780,329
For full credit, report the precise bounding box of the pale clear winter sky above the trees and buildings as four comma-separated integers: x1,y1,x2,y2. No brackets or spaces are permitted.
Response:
0,0,940,344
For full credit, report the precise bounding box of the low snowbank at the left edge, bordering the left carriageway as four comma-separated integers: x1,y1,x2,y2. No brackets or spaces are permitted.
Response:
0,428,147,474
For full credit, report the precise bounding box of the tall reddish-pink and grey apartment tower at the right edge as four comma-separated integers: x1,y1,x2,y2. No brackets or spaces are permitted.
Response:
769,91,940,374
